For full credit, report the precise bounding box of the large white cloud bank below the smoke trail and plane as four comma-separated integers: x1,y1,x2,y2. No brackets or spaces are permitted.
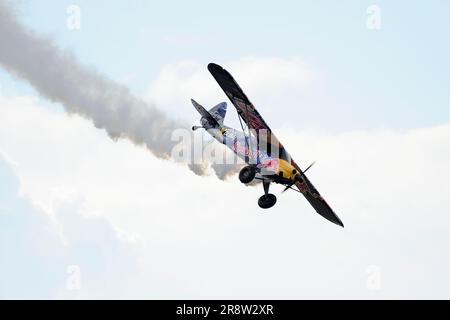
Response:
0,96,450,299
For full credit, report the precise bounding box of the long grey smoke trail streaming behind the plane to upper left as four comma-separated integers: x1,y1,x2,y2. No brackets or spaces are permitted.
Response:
0,1,232,178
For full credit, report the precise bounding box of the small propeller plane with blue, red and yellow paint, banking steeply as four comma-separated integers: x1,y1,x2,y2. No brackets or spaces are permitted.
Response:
191,63,344,227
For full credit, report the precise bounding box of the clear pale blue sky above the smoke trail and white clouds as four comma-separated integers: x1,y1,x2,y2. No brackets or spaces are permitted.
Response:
2,1,450,129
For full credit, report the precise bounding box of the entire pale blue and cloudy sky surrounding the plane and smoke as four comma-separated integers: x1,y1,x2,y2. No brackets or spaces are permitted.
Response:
0,0,450,299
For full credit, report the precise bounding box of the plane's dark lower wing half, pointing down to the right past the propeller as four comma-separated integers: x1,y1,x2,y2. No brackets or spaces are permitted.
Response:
292,161,344,227
